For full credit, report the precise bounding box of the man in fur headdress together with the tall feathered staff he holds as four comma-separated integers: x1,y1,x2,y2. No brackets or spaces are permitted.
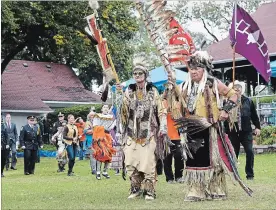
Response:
136,0,252,201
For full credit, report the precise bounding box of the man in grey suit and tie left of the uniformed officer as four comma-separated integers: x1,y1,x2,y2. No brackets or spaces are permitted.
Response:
5,114,18,170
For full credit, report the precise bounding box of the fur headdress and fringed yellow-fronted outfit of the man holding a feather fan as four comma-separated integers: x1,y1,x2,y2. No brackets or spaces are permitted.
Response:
172,52,239,201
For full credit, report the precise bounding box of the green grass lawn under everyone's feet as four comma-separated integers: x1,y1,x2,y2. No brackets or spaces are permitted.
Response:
2,154,276,209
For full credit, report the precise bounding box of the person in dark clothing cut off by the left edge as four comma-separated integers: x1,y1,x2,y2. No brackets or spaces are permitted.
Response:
1,120,10,177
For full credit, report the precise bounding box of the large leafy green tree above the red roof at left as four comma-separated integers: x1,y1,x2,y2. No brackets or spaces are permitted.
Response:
1,1,138,88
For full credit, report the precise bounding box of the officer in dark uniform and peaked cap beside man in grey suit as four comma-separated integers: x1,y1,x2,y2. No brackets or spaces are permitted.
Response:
20,116,43,175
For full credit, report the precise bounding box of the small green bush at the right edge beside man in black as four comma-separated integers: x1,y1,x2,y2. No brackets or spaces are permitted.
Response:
256,126,276,145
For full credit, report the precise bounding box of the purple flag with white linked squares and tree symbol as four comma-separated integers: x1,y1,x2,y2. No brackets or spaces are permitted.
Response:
229,5,271,82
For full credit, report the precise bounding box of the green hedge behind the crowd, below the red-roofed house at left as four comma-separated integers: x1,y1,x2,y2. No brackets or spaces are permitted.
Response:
47,104,102,124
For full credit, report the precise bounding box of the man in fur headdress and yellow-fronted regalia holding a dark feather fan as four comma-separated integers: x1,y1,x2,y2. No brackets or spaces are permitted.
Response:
169,51,250,201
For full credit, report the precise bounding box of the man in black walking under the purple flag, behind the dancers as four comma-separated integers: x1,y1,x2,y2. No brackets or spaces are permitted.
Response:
225,81,261,180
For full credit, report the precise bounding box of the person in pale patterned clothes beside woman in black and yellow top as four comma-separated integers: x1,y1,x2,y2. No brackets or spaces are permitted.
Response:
52,121,67,173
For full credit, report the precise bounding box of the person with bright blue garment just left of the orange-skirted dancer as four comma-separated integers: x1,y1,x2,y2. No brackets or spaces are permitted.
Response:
84,111,97,174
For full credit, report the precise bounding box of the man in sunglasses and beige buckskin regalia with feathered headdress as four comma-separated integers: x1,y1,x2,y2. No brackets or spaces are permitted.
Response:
117,56,167,200
